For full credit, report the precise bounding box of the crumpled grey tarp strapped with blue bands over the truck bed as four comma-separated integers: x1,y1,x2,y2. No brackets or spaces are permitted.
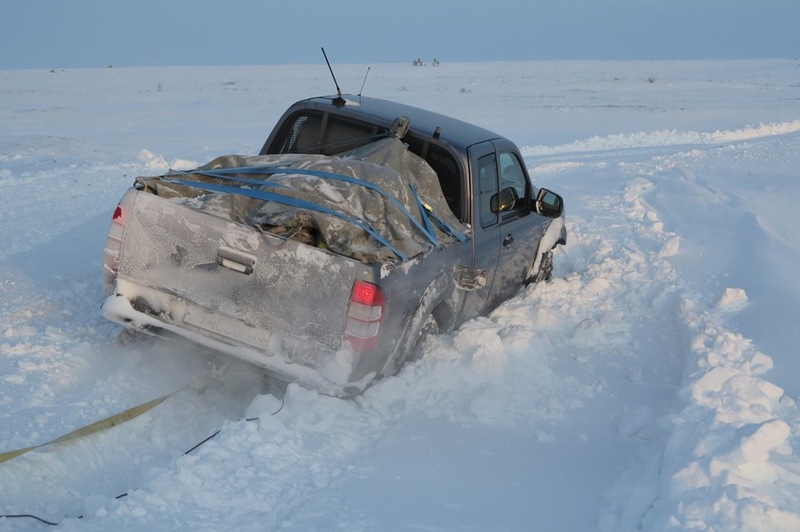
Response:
138,137,468,262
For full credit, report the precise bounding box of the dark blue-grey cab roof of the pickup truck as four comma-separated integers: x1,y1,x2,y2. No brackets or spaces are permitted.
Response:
292,94,503,152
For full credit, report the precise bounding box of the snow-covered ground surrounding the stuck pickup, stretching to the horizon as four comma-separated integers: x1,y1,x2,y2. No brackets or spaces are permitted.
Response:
0,60,800,531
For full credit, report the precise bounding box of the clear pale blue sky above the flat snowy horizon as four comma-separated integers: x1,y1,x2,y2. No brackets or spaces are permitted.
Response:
0,0,800,69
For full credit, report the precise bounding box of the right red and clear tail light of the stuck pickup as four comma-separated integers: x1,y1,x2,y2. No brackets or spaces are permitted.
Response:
344,280,385,351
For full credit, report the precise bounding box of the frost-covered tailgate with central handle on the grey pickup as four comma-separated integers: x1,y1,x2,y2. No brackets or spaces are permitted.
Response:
118,192,365,354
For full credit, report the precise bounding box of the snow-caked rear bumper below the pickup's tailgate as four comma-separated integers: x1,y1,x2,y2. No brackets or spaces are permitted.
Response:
102,283,374,397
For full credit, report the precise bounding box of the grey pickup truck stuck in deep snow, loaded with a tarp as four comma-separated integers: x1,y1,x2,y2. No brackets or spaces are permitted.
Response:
102,94,566,395
